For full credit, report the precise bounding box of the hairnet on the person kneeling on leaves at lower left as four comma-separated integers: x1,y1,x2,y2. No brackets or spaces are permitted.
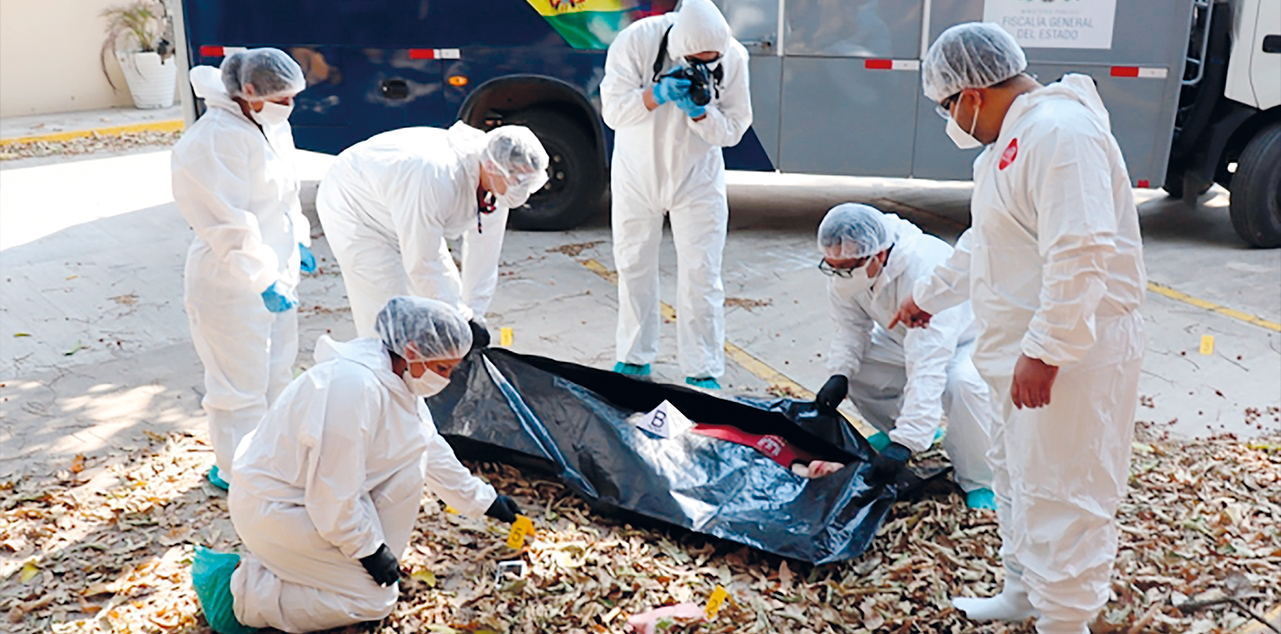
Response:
374,297,471,361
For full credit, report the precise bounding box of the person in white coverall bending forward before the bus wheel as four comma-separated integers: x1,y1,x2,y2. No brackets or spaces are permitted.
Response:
316,122,548,347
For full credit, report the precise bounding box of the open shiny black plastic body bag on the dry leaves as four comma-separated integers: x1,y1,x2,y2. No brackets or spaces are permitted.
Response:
427,348,938,564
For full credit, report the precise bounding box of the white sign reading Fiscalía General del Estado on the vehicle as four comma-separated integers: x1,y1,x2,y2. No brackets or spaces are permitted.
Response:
983,0,1117,49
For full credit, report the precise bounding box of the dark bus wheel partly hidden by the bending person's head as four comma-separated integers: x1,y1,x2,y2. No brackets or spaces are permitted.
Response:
503,108,605,231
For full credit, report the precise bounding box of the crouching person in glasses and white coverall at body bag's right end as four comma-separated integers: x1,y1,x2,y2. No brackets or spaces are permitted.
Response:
815,202,995,510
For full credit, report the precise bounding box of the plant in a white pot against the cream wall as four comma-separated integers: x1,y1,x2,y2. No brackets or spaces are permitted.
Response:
99,0,177,109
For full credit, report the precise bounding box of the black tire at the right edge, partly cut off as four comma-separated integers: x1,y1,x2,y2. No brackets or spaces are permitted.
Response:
1228,123,1281,248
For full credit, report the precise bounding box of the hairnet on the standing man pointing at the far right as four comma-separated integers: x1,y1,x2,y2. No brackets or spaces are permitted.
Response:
921,22,1027,102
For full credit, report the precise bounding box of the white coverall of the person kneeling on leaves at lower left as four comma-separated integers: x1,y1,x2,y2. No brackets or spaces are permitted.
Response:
228,337,497,633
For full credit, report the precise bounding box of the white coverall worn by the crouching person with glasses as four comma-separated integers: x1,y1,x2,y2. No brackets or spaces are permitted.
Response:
828,214,994,492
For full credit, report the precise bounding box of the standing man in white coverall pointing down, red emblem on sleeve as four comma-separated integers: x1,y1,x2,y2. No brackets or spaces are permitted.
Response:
897,23,1145,634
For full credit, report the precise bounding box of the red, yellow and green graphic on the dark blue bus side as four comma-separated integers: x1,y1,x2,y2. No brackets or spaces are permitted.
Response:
525,0,676,50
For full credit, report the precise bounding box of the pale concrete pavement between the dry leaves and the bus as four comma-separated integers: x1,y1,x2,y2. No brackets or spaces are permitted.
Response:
0,145,1281,480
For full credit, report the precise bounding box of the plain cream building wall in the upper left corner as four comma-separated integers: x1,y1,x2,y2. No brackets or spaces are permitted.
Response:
0,0,178,117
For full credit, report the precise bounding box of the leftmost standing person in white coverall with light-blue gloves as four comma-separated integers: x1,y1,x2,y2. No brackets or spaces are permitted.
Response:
170,49,315,489
